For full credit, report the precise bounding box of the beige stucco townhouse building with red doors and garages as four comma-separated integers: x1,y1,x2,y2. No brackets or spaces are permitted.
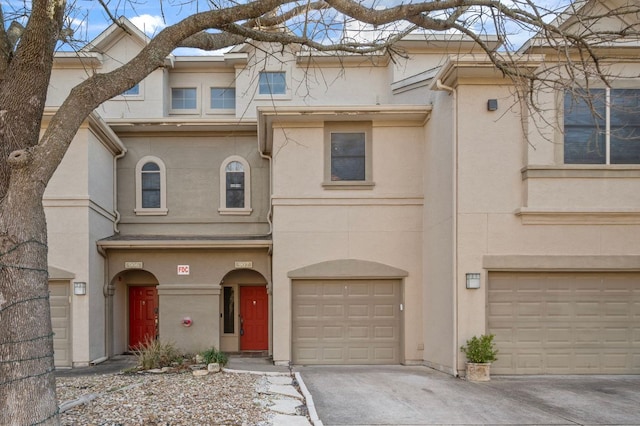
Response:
45,2,640,374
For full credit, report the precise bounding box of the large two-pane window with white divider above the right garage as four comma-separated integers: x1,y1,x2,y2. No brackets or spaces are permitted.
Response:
564,88,640,164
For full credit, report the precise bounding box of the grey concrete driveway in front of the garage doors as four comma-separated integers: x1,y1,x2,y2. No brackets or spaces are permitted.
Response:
296,366,640,426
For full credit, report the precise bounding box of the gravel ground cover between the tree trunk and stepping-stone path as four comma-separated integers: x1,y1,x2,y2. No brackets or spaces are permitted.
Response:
56,372,271,426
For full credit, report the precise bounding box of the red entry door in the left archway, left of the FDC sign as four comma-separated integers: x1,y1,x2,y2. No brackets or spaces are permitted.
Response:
129,286,158,348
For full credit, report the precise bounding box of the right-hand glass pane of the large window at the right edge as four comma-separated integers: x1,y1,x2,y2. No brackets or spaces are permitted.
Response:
610,89,640,164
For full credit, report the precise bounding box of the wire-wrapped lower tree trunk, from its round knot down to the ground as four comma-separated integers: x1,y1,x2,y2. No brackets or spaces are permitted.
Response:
0,151,59,425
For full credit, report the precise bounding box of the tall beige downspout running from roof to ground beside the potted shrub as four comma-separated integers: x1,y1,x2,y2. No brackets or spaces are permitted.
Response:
436,79,458,377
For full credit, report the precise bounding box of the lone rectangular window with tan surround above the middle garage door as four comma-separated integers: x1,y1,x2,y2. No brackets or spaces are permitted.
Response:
324,123,373,187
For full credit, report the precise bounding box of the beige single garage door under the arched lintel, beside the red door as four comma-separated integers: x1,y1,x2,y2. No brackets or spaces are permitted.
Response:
292,280,401,364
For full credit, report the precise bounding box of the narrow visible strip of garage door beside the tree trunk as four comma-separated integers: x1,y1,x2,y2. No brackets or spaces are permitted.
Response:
49,282,71,367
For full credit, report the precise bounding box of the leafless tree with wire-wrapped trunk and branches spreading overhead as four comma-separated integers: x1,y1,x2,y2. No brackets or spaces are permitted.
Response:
0,0,640,424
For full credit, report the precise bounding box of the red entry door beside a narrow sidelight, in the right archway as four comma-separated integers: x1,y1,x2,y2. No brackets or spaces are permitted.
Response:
240,286,269,351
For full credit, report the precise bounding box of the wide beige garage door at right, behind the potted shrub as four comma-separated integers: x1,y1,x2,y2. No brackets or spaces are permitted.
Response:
488,273,640,374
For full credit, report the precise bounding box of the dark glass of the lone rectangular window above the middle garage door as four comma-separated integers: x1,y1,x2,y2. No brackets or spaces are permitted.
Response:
331,133,366,181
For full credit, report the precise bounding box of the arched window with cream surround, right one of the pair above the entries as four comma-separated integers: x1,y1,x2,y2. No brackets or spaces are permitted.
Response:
218,155,251,215
